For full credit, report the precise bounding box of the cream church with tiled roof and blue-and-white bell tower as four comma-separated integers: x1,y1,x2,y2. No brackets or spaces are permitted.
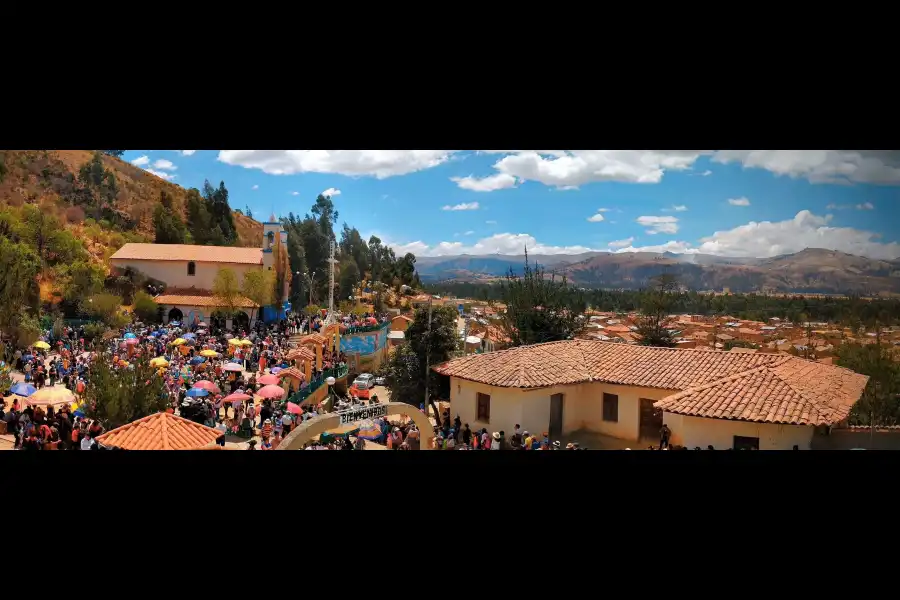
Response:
109,215,289,329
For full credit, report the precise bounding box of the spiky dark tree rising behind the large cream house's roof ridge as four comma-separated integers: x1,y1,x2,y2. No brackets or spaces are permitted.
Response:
496,250,586,346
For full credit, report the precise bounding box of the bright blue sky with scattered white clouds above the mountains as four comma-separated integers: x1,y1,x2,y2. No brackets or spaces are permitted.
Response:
123,150,900,259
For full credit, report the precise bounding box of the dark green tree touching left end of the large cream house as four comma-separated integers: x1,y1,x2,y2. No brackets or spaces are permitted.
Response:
385,306,459,415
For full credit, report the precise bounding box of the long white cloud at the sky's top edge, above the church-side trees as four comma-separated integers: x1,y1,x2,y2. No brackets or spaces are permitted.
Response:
219,150,453,179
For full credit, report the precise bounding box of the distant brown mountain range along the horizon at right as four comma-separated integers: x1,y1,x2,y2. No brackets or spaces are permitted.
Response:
416,248,900,294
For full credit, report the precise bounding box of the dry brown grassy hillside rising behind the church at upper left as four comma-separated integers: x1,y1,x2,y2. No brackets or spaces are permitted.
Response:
0,150,262,266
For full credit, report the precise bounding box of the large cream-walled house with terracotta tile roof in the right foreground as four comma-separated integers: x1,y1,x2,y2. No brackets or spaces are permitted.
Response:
434,340,868,450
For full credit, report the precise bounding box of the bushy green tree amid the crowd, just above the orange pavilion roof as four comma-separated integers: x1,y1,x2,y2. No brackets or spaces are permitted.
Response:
82,352,168,430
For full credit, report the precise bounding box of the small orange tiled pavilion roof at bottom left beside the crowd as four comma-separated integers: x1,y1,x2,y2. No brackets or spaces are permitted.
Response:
97,412,222,450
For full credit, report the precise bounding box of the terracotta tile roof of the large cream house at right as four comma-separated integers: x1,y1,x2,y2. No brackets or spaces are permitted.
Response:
434,340,868,425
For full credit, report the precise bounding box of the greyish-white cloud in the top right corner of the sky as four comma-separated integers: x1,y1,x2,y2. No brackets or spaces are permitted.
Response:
713,150,900,185
